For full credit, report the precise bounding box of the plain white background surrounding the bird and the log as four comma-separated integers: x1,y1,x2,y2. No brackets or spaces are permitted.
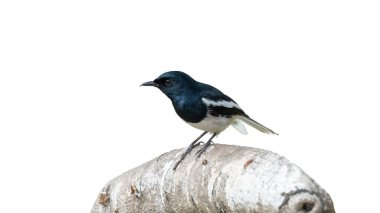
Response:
0,0,380,213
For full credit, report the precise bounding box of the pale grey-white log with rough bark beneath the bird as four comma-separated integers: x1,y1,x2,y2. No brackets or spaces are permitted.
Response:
91,144,335,213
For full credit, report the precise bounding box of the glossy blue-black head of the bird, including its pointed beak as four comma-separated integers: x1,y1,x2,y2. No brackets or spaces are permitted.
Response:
141,71,196,98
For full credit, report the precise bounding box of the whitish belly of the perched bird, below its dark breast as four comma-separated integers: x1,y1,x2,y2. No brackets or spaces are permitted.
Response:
186,115,233,133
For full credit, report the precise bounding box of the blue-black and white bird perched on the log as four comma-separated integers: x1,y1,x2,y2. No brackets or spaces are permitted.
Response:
140,71,278,170
